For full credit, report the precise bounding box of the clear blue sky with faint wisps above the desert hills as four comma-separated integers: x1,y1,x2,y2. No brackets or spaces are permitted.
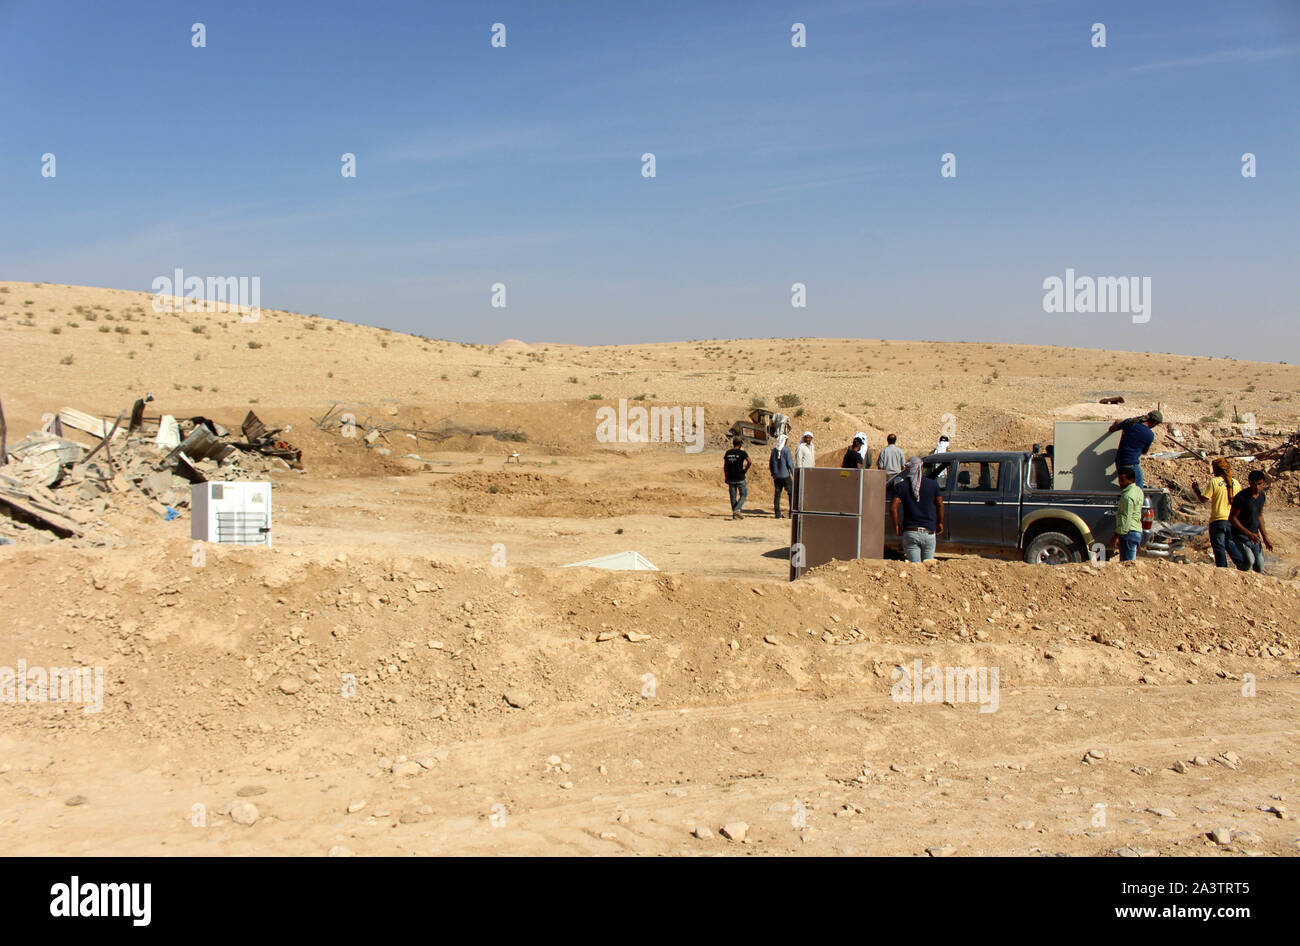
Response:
0,0,1300,364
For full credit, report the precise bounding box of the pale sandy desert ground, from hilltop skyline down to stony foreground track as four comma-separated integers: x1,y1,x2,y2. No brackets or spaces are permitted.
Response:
0,283,1300,855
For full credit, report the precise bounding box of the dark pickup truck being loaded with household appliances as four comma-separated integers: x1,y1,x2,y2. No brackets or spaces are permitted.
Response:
885,451,1180,565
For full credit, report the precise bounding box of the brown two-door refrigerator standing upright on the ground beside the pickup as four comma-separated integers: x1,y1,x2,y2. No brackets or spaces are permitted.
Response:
790,467,888,581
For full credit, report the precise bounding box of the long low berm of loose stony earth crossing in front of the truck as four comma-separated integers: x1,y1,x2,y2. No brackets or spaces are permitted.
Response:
0,542,1300,751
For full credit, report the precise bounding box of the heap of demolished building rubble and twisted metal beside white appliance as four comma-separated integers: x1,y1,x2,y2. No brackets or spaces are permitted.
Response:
0,395,302,546
